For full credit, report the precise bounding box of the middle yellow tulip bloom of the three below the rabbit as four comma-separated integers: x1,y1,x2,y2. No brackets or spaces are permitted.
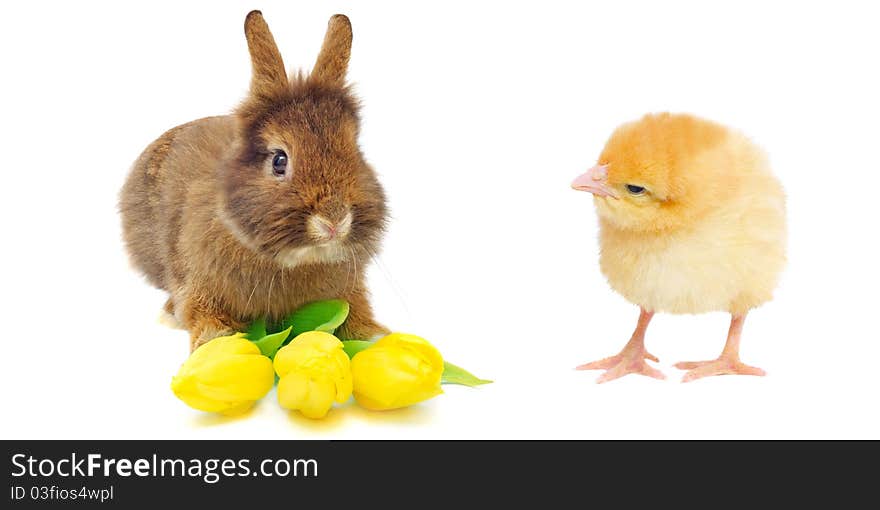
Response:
275,331,352,418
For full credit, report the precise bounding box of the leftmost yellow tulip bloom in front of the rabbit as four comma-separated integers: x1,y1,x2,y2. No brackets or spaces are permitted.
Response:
171,333,275,414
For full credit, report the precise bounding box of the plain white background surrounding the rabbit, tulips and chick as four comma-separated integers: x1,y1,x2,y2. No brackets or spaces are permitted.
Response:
0,0,880,439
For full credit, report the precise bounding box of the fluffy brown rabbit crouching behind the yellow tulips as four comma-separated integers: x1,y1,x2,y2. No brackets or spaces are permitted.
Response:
120,11,387,349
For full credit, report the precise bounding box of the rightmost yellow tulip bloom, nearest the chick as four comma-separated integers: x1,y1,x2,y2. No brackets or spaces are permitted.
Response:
351,333,443,411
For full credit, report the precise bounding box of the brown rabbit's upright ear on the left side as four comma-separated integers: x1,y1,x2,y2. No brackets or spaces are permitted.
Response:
244,11,287,98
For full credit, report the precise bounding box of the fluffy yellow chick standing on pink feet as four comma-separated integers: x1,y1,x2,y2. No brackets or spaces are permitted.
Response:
572,113,786,383
